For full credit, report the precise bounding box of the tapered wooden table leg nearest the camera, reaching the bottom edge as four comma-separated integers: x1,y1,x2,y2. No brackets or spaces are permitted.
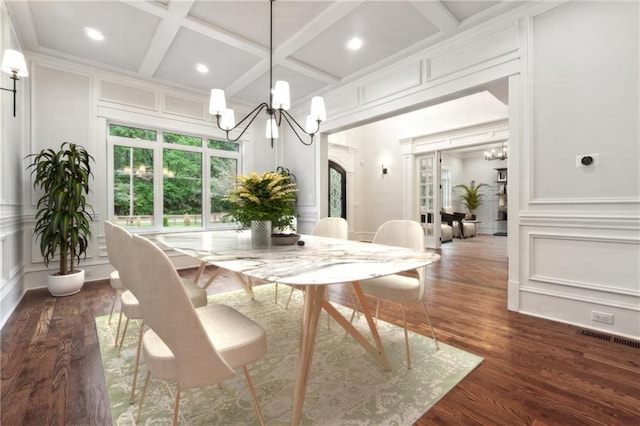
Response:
291,285,326,426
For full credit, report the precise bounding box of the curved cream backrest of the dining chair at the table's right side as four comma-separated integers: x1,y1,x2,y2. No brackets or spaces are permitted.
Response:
372,220,426,295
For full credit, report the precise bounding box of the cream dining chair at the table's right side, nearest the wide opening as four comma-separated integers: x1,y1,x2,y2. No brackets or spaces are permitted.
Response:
360,220,439,368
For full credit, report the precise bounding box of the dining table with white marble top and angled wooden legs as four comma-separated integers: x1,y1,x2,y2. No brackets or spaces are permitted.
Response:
156,230,440,425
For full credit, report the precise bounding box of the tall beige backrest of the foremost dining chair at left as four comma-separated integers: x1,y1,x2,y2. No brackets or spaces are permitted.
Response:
129,235,235,388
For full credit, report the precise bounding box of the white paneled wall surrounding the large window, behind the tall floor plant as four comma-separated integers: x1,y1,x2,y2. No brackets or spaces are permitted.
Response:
0,49,280,324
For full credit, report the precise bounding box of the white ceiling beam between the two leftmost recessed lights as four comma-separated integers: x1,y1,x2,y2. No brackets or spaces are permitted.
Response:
138,0,194,78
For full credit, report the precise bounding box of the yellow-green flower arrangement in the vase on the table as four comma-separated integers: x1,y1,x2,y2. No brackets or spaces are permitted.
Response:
223,168,298,229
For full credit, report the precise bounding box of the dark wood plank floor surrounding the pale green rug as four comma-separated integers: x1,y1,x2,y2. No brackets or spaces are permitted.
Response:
0,236,640,426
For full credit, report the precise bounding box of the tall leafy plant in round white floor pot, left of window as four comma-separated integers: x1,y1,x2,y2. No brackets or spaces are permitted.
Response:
26,142,93,296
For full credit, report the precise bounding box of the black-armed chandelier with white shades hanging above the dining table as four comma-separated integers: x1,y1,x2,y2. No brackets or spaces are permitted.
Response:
209,0,327,147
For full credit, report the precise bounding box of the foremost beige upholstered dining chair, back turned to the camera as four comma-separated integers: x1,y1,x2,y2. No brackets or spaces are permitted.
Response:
125,235,267,425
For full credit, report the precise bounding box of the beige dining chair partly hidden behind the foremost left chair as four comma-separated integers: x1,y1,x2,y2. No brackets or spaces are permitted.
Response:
104,221,207,404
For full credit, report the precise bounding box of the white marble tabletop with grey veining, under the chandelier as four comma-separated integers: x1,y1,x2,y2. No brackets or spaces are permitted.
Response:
157,231,440,285
